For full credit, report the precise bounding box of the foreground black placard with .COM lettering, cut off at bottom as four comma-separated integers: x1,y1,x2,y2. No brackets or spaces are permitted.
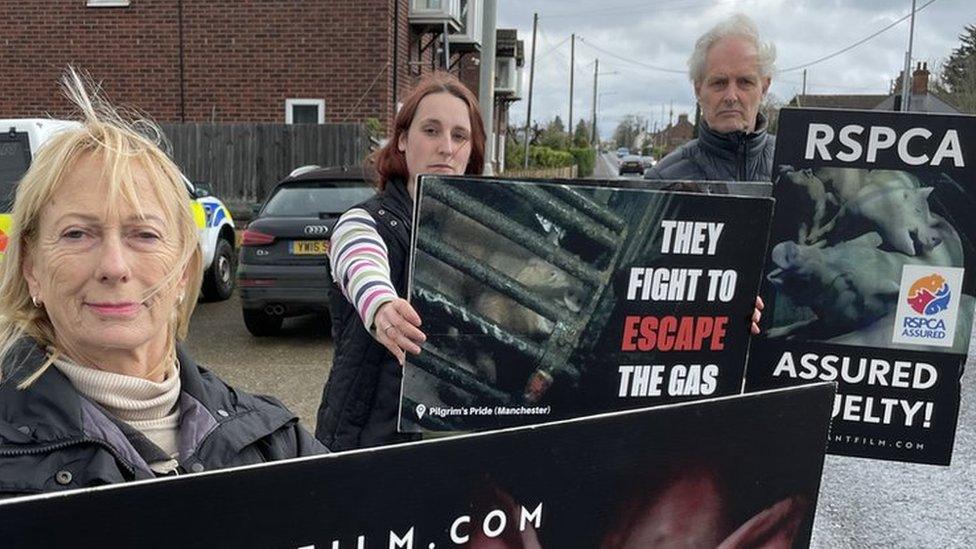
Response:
0,383,833,549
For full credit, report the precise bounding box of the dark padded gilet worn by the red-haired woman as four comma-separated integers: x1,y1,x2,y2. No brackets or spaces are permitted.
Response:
315,180,416,451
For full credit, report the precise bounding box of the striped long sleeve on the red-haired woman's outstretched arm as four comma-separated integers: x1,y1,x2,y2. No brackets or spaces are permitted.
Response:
329,208,397,333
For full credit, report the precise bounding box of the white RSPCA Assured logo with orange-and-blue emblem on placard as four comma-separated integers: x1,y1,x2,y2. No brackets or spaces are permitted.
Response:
892,265,963,347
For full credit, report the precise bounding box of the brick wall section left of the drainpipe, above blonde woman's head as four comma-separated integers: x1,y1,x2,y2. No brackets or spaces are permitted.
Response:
0,0,179,120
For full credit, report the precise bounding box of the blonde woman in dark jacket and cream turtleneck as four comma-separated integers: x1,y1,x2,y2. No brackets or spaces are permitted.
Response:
0,71,326,496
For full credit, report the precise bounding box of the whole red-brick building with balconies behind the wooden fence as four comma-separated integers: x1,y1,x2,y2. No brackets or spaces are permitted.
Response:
0,0,520,150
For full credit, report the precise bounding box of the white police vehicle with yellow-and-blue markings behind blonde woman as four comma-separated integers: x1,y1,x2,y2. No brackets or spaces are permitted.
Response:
0,118,235,301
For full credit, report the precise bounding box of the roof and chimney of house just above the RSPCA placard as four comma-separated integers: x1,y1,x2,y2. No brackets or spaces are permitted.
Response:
788,63,960,113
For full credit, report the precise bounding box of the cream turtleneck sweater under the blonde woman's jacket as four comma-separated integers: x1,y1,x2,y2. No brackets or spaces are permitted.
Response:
54,357,180,474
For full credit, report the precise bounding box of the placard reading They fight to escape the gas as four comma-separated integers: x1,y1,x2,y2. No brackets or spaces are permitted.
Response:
400,177,773,432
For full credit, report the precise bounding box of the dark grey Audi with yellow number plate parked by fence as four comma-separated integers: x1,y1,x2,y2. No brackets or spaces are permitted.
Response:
237,167,376,337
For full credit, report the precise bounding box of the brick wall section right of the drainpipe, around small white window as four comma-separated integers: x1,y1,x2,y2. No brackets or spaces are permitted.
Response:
184,0,390,122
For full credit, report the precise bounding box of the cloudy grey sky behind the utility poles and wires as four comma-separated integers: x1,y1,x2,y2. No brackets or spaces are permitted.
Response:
497,0,976,138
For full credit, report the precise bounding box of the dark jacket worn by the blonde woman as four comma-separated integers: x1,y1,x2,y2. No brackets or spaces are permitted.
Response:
0,339,328,497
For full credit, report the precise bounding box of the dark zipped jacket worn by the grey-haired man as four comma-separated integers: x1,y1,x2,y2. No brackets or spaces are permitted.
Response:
644,114,776,181
